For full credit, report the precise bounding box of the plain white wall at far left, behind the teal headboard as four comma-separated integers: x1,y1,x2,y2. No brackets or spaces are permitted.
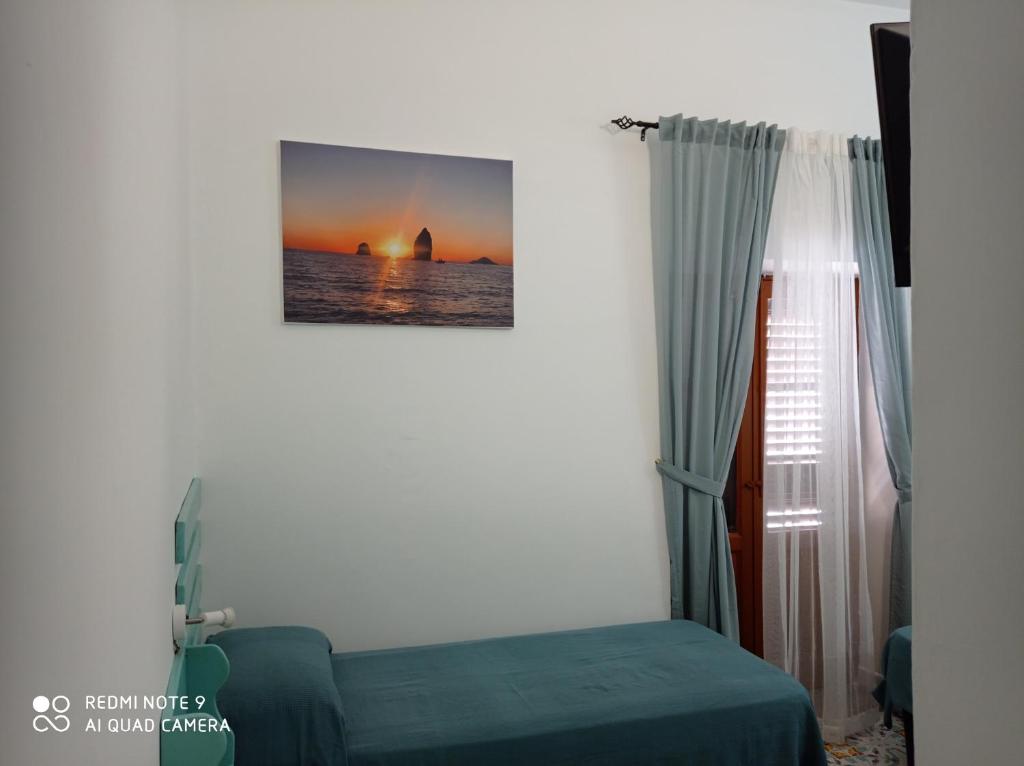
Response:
0,0,195,766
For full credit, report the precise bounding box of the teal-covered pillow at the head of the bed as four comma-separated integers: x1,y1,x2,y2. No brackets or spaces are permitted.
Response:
207,627,346,766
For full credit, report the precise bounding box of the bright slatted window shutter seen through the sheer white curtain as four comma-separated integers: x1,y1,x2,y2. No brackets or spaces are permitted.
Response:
765,300,822,529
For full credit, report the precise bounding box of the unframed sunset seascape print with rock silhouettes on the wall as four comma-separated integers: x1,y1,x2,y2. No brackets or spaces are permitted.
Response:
281,141,513,327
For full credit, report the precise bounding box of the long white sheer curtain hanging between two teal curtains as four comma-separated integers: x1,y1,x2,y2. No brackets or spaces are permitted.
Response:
764,129,878,741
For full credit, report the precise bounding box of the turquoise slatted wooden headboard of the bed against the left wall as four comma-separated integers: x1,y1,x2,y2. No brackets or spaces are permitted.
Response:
160,478,234,766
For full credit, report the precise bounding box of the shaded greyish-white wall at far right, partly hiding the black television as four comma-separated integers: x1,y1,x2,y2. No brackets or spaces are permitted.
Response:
910,0,1024,766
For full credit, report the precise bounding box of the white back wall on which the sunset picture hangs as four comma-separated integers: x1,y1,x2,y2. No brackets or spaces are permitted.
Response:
185,0,905,649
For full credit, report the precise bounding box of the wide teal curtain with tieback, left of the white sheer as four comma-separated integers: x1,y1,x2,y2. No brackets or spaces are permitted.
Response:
650,115,785,641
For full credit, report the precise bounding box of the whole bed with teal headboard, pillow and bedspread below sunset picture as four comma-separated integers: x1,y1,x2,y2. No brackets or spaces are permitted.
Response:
160,479,825,766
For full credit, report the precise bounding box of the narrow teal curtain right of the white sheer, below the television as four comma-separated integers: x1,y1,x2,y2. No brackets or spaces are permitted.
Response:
850,138,912,631
